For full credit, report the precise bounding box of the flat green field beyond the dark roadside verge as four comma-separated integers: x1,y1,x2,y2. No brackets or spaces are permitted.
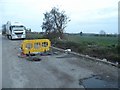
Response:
67,35,118,46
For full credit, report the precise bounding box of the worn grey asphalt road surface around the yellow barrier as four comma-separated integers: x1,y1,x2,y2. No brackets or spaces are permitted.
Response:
2,36,118,88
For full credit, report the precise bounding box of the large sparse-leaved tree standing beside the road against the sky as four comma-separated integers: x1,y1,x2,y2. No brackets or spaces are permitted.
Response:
42,7,70,38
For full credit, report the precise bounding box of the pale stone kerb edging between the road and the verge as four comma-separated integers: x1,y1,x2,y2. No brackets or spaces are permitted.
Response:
51,46,118,67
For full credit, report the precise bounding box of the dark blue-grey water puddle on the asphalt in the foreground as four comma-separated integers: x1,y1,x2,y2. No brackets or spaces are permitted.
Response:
80,76,118,88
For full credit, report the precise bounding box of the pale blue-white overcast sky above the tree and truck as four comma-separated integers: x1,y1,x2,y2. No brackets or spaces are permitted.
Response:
0,0,119,33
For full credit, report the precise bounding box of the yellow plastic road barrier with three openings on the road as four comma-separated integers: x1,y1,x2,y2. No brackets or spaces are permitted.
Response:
21,39,51,54
